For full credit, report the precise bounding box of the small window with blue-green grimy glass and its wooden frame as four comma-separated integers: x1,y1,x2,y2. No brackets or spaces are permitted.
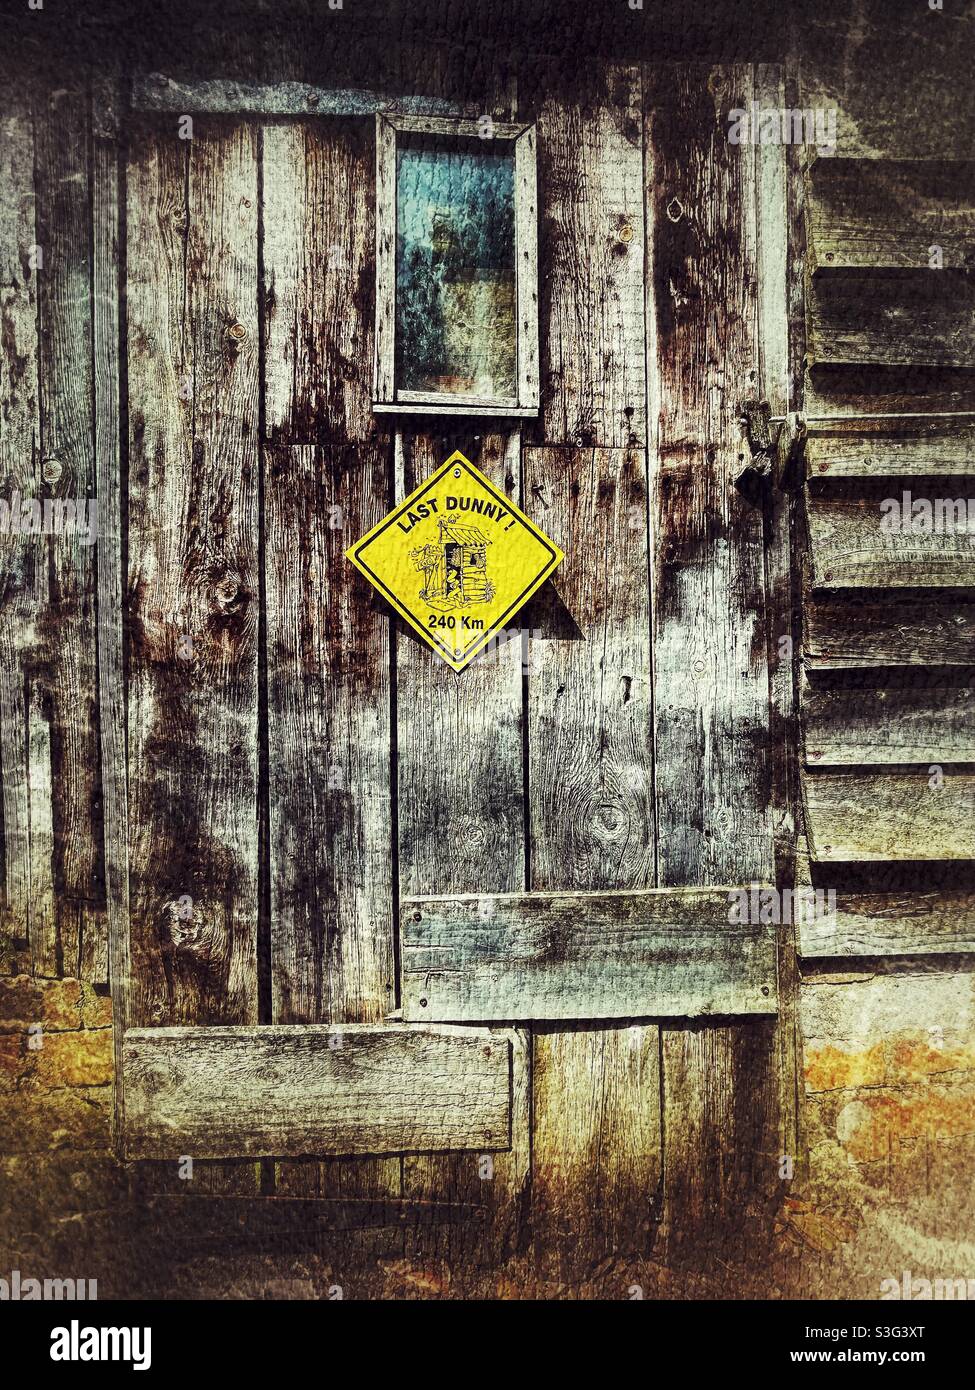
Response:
374,115,538,416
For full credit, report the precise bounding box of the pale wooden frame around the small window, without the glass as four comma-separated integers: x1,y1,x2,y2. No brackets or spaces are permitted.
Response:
373,113,538,418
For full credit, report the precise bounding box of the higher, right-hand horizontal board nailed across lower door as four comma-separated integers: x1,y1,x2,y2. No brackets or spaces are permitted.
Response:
401,888,776,1022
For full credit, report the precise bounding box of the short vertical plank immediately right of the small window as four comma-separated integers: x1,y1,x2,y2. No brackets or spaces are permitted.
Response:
520,63,647,448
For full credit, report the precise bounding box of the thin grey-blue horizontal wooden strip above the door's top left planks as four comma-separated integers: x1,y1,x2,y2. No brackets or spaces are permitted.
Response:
132,72,467,118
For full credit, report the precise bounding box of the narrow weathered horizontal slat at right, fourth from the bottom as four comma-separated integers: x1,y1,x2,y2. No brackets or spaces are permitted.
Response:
803,594,975,670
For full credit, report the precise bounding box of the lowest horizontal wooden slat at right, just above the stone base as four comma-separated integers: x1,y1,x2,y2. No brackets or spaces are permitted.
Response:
800,890,975,958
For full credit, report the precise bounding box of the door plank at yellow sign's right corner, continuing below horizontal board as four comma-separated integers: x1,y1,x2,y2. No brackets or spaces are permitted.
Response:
524,449,661,1279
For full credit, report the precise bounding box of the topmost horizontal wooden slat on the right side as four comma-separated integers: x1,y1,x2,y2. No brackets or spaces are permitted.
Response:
808,158,975,271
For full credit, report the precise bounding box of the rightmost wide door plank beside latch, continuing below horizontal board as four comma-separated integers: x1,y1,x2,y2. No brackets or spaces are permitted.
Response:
644,65,777,1259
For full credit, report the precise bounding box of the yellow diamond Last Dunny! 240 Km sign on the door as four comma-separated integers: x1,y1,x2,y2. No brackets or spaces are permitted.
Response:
345,452,565,671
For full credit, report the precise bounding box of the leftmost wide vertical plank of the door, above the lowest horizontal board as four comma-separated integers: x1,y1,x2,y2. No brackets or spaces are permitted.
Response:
127,121,259,1024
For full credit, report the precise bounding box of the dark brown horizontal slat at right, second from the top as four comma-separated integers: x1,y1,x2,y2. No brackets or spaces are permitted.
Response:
809,270,975,371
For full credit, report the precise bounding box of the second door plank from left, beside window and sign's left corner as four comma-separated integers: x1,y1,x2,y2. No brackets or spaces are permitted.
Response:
261,121,402,1239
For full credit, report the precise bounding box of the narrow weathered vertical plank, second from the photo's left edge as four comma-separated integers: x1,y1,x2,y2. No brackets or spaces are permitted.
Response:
35,86,107,980
